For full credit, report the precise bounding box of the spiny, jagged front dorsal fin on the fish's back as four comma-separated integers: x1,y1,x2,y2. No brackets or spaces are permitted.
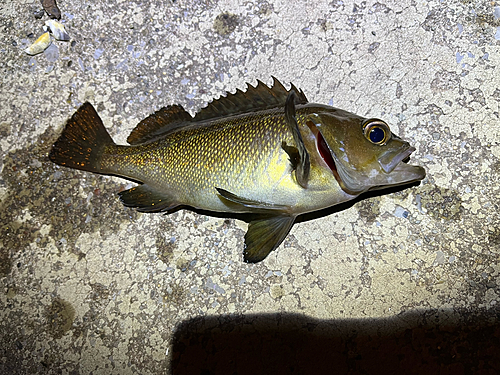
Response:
193,77,308,121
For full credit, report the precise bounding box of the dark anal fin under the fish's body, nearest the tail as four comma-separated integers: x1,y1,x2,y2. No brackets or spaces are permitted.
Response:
118,185,178,212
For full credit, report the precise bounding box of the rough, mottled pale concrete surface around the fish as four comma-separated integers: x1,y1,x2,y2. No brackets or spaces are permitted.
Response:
0,0,500,374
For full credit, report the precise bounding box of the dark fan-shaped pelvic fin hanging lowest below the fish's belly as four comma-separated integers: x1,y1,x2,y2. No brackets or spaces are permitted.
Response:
243,215,295,263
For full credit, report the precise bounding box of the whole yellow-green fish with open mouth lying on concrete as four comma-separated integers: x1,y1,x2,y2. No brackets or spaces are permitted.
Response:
49,77,426,263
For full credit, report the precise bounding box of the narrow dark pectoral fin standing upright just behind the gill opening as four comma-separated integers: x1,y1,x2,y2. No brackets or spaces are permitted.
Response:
285,91,311,188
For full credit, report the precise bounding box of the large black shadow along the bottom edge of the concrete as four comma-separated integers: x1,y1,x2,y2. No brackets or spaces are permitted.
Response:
170,310,500,375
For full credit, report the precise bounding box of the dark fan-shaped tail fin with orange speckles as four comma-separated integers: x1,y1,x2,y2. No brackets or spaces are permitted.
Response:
49,102,115,173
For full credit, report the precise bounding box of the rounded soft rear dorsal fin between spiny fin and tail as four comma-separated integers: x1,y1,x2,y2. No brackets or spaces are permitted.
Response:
127,105,193,145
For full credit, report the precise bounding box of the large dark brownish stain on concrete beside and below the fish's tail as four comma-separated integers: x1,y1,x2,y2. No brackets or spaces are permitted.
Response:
0,129,137,275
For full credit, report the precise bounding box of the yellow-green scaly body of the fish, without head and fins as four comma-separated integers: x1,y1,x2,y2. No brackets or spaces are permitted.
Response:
101,111,353,214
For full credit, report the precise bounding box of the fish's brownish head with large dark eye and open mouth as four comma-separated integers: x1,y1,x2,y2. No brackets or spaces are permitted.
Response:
306,106,425,194
